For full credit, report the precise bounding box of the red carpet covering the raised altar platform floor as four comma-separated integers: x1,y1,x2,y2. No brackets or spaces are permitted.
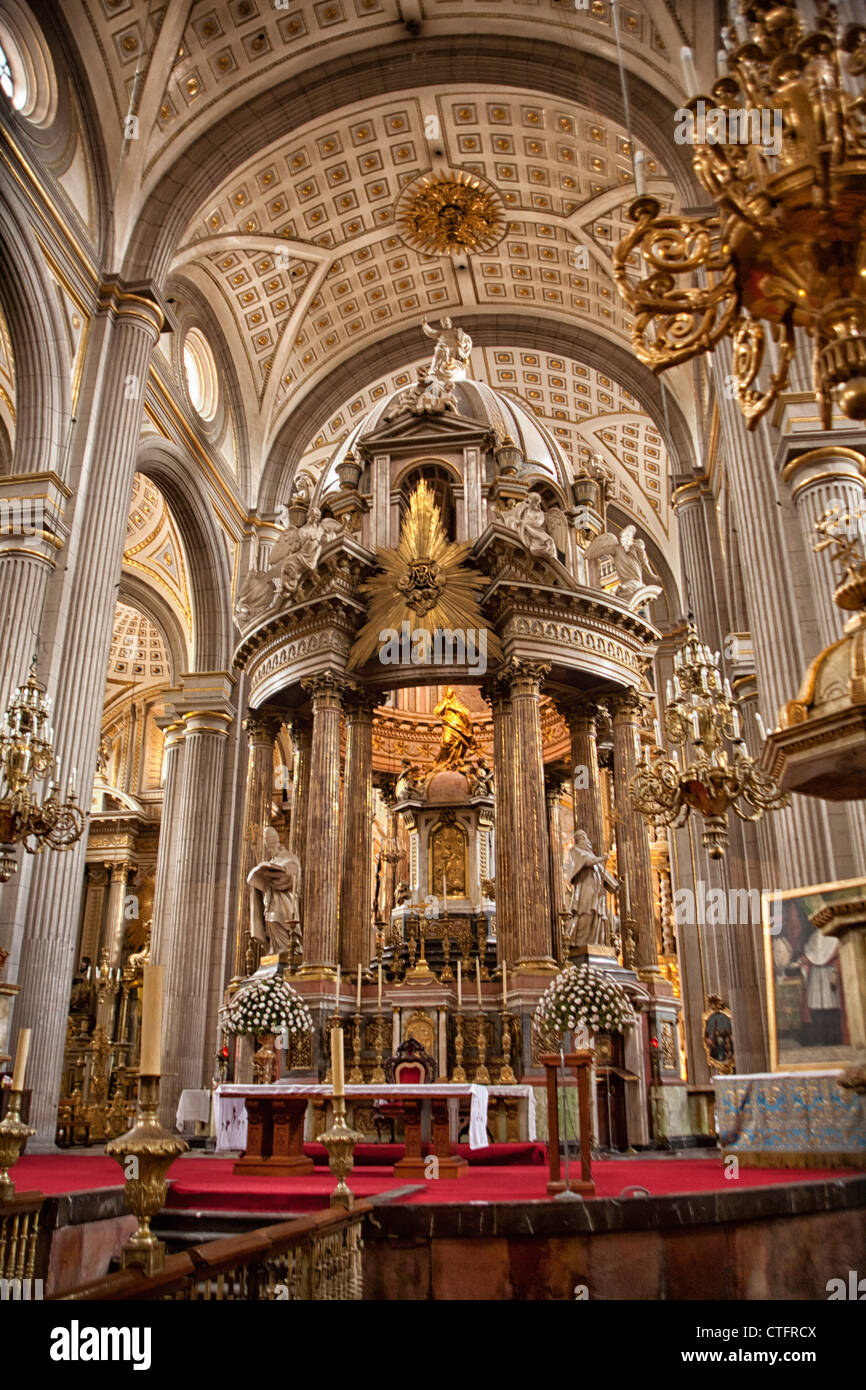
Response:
14,1144,852,1212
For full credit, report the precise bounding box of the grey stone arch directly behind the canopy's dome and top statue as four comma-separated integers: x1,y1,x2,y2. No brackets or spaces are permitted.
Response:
259,311,696,516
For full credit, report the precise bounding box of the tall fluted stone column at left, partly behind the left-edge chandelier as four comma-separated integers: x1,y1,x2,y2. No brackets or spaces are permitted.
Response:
15,282,164,1141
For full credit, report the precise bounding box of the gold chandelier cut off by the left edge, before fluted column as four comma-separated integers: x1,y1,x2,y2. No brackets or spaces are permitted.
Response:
0,666,85,883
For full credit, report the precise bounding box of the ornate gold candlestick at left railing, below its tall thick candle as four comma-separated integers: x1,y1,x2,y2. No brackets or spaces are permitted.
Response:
106,1076,189,1277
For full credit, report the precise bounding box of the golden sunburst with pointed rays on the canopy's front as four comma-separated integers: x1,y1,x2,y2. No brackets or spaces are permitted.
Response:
349,480,502,667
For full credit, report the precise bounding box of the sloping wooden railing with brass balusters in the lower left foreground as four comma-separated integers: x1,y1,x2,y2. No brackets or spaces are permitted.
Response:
53,1202,371,1302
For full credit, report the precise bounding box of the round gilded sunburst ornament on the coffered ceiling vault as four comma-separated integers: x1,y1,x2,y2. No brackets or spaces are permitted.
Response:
393,170,507,256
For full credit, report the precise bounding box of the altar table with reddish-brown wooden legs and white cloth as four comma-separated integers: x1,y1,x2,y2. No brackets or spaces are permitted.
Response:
215,1081,535,1177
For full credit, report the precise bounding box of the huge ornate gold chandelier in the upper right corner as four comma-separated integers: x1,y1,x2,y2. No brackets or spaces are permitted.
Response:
614,0,866,430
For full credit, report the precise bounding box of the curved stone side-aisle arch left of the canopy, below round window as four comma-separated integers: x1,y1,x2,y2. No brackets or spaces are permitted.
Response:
136,436,232,671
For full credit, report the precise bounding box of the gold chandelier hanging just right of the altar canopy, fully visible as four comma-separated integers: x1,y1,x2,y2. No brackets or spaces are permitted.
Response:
628,623,788,859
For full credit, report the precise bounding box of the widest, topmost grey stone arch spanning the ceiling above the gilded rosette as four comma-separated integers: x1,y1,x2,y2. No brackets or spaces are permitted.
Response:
125,32,698,281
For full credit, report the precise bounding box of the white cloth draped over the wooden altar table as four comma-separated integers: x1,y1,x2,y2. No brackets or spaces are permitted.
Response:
214,1081,535,1151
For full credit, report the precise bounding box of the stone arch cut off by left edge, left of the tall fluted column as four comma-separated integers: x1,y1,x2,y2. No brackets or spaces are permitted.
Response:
0,186,72,474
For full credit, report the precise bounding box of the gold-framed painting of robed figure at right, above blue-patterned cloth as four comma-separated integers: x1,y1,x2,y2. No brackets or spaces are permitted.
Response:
762,878,866,1072
